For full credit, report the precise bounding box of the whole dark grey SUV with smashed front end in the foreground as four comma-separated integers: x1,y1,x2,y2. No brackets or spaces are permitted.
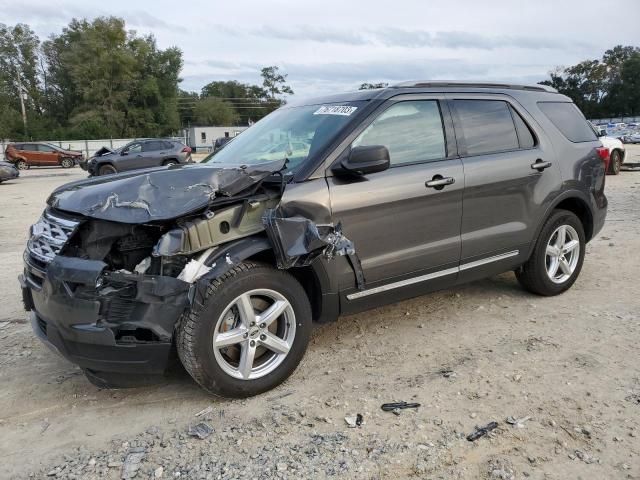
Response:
20,82,608,397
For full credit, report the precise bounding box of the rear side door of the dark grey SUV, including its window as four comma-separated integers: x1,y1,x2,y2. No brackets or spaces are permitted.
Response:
447,94,562,281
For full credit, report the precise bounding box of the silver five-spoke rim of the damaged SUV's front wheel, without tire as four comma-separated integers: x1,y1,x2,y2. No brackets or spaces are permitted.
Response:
213,289,296,380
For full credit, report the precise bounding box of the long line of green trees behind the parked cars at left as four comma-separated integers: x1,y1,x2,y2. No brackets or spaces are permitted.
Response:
0,17,293,140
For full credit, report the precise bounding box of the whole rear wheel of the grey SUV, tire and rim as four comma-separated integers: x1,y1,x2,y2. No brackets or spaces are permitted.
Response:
516,210,586,296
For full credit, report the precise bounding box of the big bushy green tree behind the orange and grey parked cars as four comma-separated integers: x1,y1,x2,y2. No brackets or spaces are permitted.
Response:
43,17,182,137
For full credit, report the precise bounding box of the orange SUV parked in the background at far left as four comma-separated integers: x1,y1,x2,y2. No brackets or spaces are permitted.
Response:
4,142,83,170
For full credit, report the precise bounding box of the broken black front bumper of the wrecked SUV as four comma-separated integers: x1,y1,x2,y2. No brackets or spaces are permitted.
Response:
19,252,189,375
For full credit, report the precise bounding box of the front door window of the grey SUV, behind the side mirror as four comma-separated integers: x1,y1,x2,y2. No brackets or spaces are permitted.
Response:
352,100,447,165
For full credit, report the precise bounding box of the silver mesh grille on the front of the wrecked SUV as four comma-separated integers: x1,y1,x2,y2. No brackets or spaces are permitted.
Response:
27,210,80,264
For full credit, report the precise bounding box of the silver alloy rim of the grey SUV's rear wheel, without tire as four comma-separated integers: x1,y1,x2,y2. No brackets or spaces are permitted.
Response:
545,225,580,283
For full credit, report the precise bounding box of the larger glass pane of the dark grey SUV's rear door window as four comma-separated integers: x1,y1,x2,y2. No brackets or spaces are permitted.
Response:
454,100,519,155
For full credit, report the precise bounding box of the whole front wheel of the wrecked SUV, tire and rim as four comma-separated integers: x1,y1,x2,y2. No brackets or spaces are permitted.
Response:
177,261,312,398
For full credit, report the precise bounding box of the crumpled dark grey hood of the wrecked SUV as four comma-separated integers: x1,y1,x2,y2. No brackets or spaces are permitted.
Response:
47,161,283,223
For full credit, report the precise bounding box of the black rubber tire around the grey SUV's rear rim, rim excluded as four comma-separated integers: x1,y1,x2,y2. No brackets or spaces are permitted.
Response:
515,209,586,296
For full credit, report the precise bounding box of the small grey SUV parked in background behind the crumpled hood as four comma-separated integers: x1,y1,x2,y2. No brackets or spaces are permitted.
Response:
80,139,193,175
